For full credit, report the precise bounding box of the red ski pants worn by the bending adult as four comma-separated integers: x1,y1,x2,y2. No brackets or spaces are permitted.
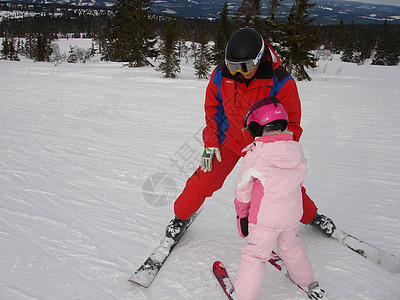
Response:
174,147,317,224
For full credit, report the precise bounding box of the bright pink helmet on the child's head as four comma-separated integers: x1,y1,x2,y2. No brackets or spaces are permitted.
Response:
243,96,289,136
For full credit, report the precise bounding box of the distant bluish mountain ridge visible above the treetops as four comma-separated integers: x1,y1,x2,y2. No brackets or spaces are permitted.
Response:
0,0,400,24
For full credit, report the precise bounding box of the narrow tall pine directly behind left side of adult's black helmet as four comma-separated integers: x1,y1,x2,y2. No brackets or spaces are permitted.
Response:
211,2,232,65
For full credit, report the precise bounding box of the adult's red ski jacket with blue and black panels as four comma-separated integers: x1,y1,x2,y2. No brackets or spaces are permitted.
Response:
203,43,302,155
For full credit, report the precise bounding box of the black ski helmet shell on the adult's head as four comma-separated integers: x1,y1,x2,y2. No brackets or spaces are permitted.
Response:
225,27,264,62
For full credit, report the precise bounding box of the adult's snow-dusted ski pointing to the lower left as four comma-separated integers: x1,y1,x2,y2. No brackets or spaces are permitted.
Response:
128,210,201,288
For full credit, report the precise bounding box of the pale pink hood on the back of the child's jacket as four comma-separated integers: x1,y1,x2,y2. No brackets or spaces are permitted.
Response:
243,133,305,169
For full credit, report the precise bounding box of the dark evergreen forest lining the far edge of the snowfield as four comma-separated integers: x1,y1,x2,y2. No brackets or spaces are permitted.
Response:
0,0,400,80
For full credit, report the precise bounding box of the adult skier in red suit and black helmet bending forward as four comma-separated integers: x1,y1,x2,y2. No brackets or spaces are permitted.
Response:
166,28,335,240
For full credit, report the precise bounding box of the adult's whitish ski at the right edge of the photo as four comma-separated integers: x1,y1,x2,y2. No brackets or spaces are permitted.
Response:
331,228,400,273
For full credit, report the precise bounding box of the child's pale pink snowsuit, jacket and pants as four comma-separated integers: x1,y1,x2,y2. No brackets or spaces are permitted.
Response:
235,133,314,300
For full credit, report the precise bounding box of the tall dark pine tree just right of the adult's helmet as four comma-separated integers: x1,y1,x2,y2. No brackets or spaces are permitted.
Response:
281,0,320,80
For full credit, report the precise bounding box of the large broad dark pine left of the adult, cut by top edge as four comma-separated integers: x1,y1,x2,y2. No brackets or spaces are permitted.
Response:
107,0,157,67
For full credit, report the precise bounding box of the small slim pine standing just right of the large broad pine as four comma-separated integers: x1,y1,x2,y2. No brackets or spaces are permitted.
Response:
157,19,181,78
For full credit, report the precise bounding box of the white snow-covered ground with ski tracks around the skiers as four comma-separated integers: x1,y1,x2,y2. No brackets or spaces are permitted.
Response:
0,40,400,300
